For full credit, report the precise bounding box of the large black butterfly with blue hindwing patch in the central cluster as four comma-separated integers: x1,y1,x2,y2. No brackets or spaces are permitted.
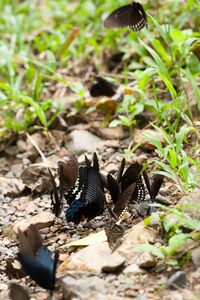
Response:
65,153,103,223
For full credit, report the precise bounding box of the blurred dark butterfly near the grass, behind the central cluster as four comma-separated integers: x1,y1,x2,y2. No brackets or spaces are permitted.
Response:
89,76,124,102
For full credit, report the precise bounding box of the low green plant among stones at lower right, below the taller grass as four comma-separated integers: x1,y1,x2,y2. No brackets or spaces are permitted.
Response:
133,204,200,265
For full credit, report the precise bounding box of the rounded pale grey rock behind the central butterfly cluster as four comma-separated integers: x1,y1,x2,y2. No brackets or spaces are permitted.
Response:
65,130,102,156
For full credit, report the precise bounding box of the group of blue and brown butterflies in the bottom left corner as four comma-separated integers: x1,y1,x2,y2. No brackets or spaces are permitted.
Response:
10,225,59,300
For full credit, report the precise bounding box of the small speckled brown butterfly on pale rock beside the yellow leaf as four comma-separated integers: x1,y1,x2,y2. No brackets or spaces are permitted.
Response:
105,219,124,252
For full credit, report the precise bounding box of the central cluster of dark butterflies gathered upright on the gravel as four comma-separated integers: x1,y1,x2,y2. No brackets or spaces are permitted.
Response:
49,153,163,250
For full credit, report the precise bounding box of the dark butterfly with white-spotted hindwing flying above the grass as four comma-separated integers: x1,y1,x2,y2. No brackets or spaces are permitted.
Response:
104,1,148,31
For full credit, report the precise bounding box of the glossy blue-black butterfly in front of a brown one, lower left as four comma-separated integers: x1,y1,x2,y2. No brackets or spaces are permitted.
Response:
17,247,59,295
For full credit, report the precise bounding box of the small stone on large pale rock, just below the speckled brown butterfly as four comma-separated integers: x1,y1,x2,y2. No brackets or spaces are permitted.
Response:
101,252,125,273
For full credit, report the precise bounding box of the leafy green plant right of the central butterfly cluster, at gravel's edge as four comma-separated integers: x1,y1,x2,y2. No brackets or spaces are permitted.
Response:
144,123,199,192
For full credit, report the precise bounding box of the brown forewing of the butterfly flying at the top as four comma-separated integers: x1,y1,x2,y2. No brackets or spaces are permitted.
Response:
104,4,132,29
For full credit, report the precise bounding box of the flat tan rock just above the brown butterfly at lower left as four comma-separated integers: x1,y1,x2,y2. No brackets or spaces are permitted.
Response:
14,212,55,234
